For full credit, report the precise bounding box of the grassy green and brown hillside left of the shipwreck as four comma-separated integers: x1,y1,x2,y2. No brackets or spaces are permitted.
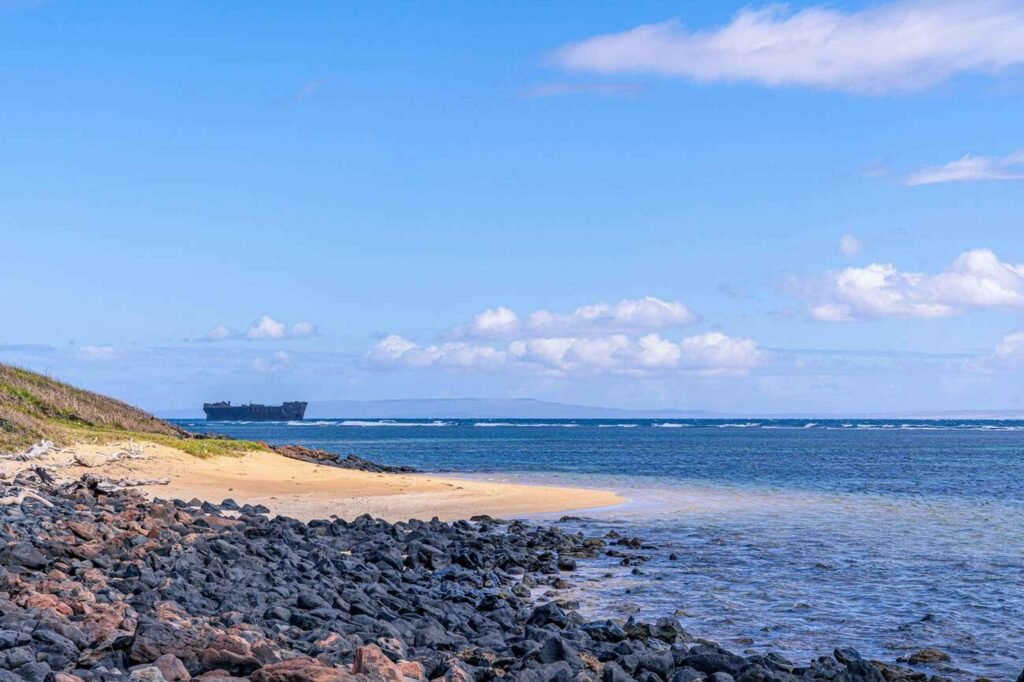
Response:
0,364,260,457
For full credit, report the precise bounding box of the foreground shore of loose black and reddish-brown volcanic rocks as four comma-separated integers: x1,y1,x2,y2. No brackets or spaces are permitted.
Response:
0,469,1007,682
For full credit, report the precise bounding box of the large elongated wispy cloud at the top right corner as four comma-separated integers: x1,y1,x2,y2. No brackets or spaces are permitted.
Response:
555,0,1024,93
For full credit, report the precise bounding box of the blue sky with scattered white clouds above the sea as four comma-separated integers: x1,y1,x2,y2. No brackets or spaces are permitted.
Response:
0,0,1024,414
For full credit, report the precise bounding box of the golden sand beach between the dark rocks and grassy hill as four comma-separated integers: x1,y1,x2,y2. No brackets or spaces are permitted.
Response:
0,442,625,521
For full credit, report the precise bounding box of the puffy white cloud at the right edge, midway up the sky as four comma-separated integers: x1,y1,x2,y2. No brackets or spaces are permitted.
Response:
800,249,1024,322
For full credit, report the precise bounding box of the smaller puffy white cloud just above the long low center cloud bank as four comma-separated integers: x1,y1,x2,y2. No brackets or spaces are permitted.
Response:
452,296,696,339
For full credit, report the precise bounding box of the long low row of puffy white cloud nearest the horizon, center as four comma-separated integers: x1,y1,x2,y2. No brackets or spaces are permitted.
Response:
367,333,763,375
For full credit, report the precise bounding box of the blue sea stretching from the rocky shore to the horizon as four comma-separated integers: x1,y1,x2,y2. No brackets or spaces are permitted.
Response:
172,419,1024,680
